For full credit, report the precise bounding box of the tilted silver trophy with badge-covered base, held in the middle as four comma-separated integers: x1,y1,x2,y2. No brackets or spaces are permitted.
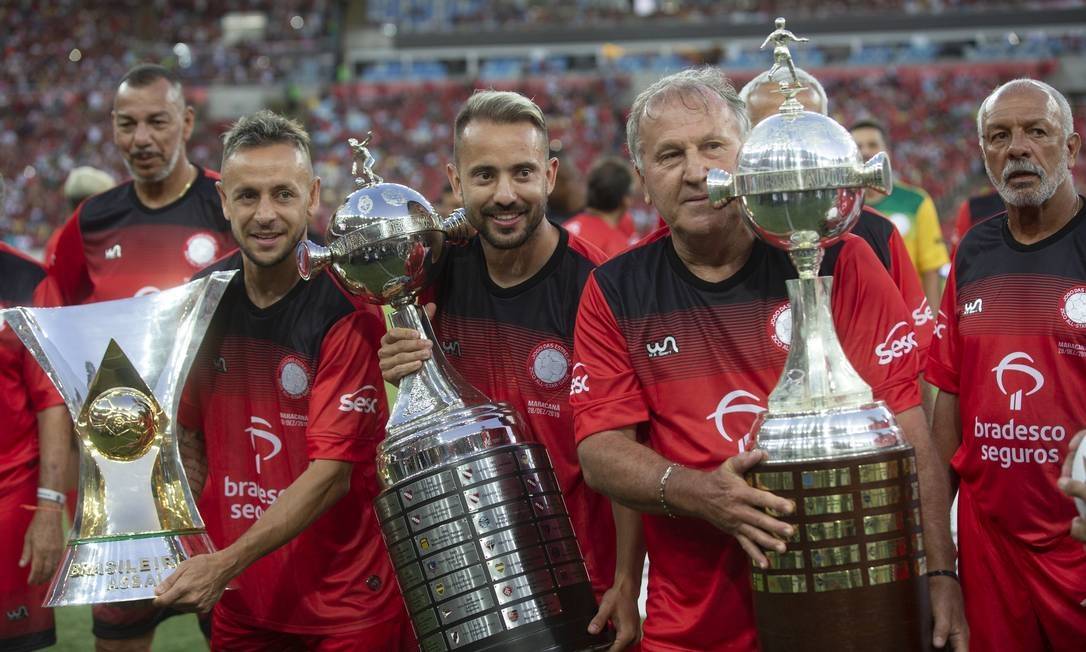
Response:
298,138,607,652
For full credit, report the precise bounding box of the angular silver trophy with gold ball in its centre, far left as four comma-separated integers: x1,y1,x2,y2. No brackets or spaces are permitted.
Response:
0,272,233,606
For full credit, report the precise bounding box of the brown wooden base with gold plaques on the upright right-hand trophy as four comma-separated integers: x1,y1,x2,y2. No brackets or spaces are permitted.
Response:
748,446,932,652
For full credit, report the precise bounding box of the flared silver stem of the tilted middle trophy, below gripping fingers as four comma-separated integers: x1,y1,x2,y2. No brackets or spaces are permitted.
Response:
386,303,488,439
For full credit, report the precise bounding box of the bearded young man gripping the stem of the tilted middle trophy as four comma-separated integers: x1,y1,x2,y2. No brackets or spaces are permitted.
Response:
380,91,643,650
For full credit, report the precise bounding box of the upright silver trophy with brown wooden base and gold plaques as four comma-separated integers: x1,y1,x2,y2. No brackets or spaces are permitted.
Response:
708,18,931,652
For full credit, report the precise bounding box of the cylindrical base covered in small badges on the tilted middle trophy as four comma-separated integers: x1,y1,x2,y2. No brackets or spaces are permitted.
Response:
375,443,608,652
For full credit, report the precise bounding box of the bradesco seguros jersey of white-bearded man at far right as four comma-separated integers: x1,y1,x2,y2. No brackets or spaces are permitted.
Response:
927,199,1086,549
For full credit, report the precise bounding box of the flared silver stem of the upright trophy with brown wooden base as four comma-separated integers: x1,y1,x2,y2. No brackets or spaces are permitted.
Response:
769,276,873,413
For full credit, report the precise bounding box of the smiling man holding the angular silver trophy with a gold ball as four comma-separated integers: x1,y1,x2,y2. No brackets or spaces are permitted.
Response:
154,111,414,651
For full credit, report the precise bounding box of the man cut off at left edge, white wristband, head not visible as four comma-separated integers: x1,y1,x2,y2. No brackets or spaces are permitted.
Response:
0,242,72,650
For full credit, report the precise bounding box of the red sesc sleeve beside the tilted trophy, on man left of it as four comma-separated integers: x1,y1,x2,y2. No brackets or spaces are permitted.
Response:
306,310,388,463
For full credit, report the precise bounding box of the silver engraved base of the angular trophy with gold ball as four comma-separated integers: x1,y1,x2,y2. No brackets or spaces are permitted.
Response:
45,529,215,607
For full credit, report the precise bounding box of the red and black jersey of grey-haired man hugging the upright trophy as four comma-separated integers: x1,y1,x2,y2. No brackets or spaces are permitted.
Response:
570,233,920,650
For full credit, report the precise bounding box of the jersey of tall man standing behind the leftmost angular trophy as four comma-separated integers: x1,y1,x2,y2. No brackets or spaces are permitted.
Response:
47,167,237,305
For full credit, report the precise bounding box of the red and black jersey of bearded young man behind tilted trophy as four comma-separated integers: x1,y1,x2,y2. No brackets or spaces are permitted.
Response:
425,227,615,592
